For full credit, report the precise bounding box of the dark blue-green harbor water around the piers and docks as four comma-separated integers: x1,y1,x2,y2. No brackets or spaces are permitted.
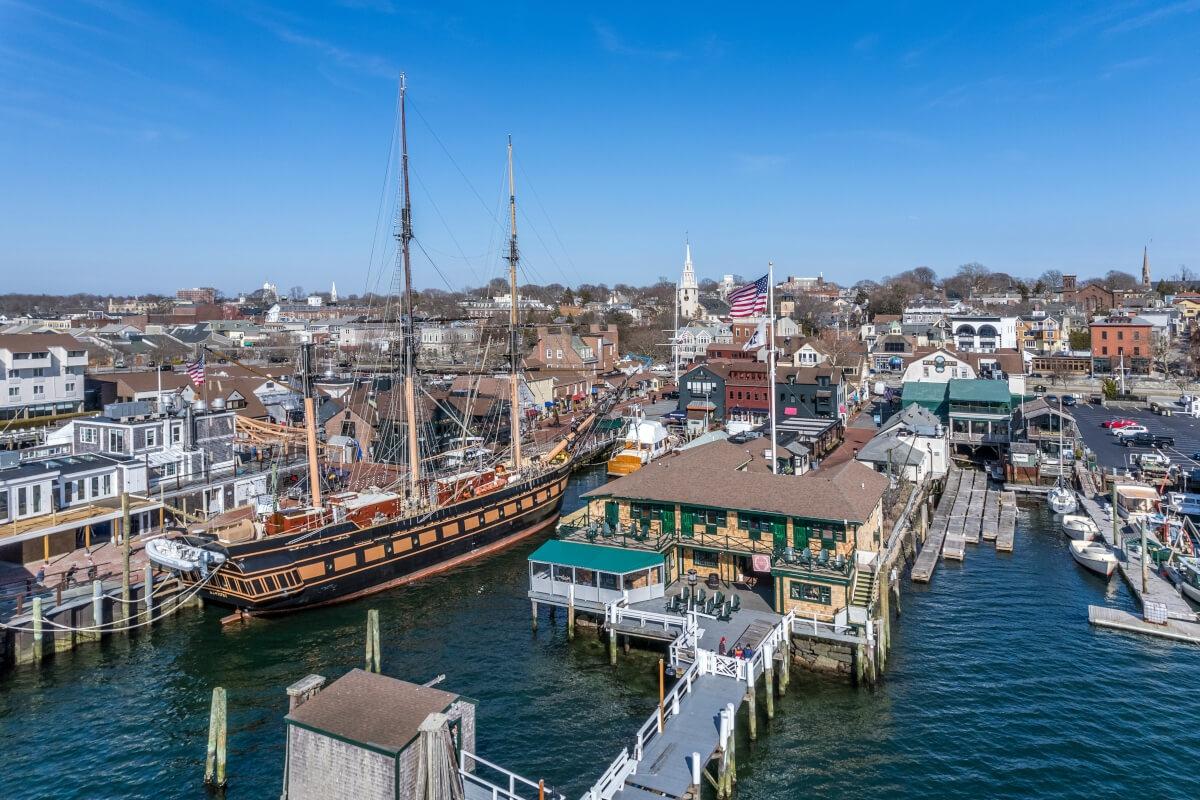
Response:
0,468,1200,800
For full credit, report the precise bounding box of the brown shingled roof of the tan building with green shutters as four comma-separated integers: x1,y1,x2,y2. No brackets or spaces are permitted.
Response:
584,441,888,523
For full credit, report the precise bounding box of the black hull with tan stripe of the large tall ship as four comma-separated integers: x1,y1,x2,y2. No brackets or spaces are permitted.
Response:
185,463,571,614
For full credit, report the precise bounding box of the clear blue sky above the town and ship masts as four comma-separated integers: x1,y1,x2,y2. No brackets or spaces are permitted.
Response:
0,0,1200,293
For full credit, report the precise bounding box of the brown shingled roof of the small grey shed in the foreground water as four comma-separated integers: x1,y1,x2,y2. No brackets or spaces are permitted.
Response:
286,669,458,754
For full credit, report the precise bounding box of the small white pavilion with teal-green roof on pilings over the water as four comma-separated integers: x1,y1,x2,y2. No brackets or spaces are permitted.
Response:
529,540,665,606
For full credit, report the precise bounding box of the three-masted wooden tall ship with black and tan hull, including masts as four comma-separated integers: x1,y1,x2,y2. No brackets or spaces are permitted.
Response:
146,79,616,614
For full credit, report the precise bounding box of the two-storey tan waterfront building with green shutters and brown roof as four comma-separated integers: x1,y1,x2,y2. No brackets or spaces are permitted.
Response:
559,439,888,620
